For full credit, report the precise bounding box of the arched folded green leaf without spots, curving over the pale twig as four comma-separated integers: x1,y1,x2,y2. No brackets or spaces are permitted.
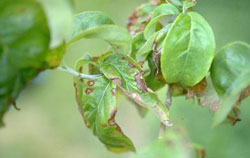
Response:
68,12,132,53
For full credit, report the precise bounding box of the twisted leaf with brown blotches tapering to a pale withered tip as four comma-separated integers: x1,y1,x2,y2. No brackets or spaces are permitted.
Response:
98,52,171,126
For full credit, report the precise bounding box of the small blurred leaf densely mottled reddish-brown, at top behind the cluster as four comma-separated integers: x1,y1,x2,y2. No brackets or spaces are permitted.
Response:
127,3,156,35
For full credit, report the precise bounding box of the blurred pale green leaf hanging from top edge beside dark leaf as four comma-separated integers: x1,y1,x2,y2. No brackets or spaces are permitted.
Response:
38,0,73,49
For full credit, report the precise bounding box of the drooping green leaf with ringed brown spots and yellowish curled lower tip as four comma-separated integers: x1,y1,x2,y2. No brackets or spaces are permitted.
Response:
74,60,135,152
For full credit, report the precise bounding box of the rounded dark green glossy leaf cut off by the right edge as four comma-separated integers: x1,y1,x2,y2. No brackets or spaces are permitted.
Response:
211,42,250,96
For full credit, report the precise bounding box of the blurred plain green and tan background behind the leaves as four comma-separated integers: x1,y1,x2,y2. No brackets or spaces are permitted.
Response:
0,0,250,158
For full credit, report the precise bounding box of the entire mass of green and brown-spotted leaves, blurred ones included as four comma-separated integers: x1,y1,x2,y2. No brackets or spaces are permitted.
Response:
0,0,250,158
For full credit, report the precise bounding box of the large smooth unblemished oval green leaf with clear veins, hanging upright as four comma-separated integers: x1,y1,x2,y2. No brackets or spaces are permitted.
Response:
161,12,215,86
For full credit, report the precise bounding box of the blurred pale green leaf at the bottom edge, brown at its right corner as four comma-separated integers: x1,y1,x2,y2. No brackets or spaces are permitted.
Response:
133,128,205,158
